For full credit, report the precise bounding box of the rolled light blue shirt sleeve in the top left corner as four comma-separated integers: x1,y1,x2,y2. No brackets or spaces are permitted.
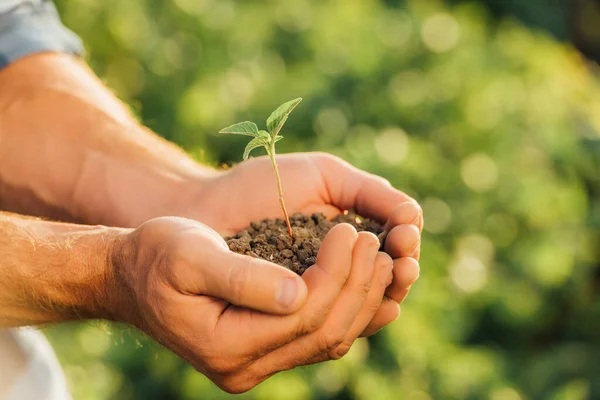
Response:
0,0,83,69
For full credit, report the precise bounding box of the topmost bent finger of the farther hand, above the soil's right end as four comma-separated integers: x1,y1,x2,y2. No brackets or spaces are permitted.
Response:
311,153,416,223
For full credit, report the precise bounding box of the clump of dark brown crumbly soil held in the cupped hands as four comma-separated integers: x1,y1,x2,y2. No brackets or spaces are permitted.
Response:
226,212,385,275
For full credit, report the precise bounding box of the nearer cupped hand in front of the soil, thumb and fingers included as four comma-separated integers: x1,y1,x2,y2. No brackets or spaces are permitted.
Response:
112,217,393,393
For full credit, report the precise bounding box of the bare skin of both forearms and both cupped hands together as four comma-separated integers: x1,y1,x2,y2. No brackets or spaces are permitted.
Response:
0,53,423,393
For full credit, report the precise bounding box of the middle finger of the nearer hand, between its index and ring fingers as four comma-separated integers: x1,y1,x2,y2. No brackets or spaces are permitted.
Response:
241,232,379,374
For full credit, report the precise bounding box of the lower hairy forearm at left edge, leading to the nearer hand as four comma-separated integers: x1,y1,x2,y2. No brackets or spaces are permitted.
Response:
0,213,124,328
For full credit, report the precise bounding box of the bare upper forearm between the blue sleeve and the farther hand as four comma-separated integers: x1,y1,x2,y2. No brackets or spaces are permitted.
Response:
0,54,219,226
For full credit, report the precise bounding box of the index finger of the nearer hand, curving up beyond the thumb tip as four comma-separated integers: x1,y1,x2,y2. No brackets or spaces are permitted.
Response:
215,224,358,359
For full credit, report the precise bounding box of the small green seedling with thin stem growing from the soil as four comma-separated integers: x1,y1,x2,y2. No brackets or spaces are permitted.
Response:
219,98,302,237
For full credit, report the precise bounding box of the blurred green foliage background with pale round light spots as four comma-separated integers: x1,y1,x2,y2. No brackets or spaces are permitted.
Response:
46,0,600,400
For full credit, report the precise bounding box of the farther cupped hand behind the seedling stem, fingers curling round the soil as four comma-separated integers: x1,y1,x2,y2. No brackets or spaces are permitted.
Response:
188,153,423,336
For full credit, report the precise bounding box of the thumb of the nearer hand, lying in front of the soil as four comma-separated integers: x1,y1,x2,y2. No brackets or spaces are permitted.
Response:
198,249,308,314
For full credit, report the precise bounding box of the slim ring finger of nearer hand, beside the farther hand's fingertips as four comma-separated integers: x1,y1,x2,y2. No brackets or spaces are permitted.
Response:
334,252,394,355
